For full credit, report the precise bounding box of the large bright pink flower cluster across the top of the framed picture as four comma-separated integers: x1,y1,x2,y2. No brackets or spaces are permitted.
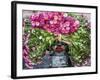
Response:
30,11,79,35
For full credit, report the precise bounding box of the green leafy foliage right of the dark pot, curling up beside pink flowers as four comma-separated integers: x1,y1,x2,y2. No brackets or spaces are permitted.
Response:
62,13,91,66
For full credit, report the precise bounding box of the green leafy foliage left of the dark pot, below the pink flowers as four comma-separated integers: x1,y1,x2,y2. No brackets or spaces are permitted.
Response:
24,26,54,62
